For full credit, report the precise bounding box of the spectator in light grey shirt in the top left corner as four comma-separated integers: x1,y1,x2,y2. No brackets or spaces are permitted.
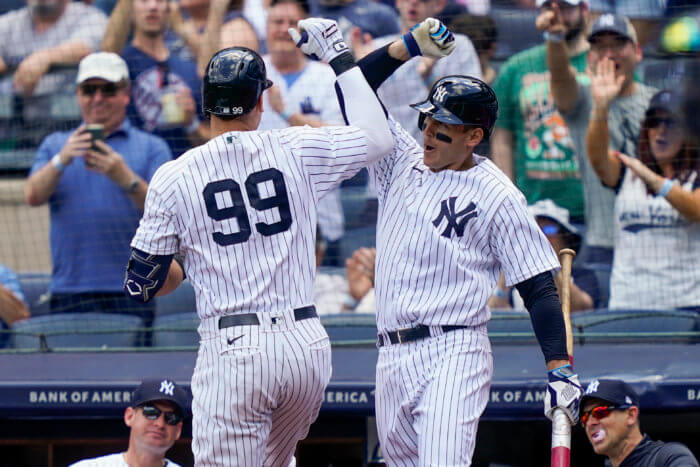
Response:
0,0,107,147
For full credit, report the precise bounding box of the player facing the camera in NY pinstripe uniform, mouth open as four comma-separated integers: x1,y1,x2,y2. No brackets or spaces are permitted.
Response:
350,31,581,466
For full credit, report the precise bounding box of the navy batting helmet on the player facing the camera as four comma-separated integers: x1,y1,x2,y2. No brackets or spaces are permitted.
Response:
411,75,498,139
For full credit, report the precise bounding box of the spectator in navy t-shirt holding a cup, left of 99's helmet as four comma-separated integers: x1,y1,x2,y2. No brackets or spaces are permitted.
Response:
102,0,209,157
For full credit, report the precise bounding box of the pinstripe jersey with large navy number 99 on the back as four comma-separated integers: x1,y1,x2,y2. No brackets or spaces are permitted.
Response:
132,127,367,338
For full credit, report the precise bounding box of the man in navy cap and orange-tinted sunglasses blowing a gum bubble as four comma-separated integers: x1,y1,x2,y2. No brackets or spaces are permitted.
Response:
580,379,698,467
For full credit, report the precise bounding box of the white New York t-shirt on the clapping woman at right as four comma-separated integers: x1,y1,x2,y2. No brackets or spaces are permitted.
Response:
609,169,700,310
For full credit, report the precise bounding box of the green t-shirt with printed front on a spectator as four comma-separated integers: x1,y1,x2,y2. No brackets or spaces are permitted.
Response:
494,45,588,219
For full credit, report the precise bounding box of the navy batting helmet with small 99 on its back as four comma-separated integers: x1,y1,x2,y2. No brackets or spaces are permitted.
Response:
202,47,272,117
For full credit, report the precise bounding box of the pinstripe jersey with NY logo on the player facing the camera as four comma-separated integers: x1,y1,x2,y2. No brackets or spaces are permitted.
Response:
369,119,559,331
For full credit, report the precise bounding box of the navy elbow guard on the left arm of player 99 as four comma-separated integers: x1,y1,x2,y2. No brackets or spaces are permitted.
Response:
124,248,173,303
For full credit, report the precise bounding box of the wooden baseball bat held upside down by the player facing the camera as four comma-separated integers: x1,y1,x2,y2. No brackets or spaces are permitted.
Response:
550,248,576,467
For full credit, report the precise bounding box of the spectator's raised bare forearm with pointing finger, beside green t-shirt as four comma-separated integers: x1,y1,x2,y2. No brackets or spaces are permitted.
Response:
535,2,578,114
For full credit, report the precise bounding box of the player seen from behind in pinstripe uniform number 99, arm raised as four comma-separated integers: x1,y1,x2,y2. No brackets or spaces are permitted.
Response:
124,18,452,466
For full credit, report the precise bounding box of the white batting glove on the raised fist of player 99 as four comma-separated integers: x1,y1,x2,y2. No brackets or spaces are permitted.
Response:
289,18,348,63
